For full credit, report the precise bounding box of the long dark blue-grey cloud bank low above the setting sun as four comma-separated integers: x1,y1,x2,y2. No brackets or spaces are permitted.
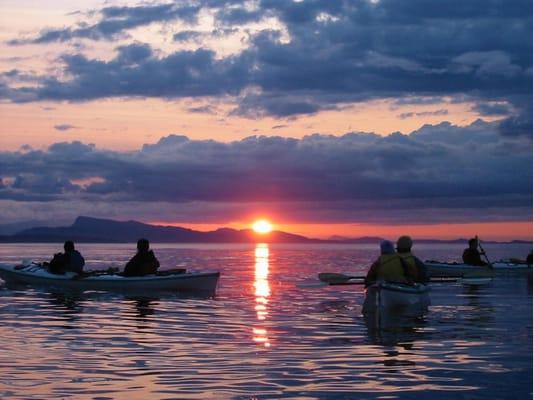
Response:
0,121,533,223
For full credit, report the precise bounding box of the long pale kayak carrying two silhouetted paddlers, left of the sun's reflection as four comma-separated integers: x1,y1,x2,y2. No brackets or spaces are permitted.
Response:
0,263,220,294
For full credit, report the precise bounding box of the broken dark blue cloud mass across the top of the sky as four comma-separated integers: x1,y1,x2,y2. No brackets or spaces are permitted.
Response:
0,0,533,130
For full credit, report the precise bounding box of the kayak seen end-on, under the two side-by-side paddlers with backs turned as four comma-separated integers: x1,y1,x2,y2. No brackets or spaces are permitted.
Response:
363,281,430,313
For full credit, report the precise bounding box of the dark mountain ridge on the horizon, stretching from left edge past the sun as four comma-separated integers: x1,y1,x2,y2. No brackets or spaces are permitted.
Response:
0,216,323,243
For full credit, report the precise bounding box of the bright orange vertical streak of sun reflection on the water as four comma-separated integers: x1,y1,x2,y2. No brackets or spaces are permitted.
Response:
252,243,270,347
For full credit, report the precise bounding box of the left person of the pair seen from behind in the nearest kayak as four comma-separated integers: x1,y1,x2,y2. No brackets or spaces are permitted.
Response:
365,240,416,286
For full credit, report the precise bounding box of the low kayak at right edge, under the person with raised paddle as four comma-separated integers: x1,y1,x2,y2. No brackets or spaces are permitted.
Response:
424,261,533,278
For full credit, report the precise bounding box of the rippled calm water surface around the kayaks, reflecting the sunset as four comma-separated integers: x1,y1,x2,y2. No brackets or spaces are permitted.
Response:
0,244,533,400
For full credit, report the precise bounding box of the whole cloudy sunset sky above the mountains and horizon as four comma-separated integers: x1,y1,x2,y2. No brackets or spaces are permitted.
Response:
0,0,533,240
